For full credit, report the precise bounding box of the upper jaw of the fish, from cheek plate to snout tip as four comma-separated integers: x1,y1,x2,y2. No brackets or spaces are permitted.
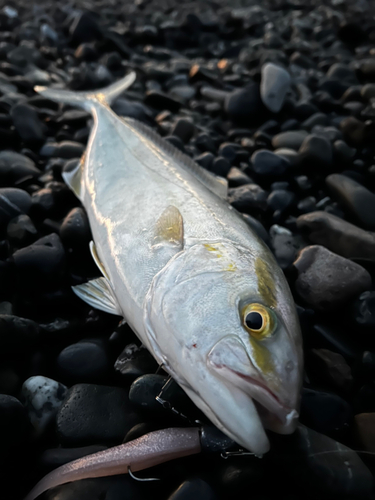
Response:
207,335,299,434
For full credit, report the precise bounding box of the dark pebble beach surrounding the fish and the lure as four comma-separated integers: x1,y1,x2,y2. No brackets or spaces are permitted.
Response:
0,0,375,500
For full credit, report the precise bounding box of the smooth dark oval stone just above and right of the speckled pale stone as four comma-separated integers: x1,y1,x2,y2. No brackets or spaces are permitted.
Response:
56,340,110,383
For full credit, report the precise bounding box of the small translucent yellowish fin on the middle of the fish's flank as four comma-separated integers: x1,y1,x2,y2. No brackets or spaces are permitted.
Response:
155,205,184,250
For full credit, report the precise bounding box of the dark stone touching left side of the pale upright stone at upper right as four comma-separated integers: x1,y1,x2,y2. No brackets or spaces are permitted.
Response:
224,83,266,122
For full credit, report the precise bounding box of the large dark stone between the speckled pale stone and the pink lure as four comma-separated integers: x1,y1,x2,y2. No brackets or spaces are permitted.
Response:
56,384,139,446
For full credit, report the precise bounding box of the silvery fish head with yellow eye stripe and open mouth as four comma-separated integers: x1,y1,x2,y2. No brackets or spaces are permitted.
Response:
146,241,302,455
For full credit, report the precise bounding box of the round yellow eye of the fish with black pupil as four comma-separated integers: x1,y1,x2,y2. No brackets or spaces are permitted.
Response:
242,304,276,340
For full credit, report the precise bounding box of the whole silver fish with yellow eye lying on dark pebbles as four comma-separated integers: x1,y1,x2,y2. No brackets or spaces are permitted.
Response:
35,72,303,456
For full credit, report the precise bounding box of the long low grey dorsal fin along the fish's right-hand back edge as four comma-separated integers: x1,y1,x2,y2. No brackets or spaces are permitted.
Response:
123,118,228,199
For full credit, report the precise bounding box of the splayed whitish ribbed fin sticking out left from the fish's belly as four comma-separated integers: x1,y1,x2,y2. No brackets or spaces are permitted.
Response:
72,278,123,316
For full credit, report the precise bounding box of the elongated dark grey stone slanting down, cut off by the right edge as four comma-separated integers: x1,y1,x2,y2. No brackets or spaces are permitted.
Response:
326,174,375,231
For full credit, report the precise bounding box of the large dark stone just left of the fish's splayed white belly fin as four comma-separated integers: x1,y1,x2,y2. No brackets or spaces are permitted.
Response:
13,233,66,289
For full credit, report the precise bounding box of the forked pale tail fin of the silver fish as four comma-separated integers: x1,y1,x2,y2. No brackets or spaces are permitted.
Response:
34,71,136,111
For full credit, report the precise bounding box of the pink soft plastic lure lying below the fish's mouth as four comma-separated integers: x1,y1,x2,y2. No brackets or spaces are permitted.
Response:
24,427,201,500
